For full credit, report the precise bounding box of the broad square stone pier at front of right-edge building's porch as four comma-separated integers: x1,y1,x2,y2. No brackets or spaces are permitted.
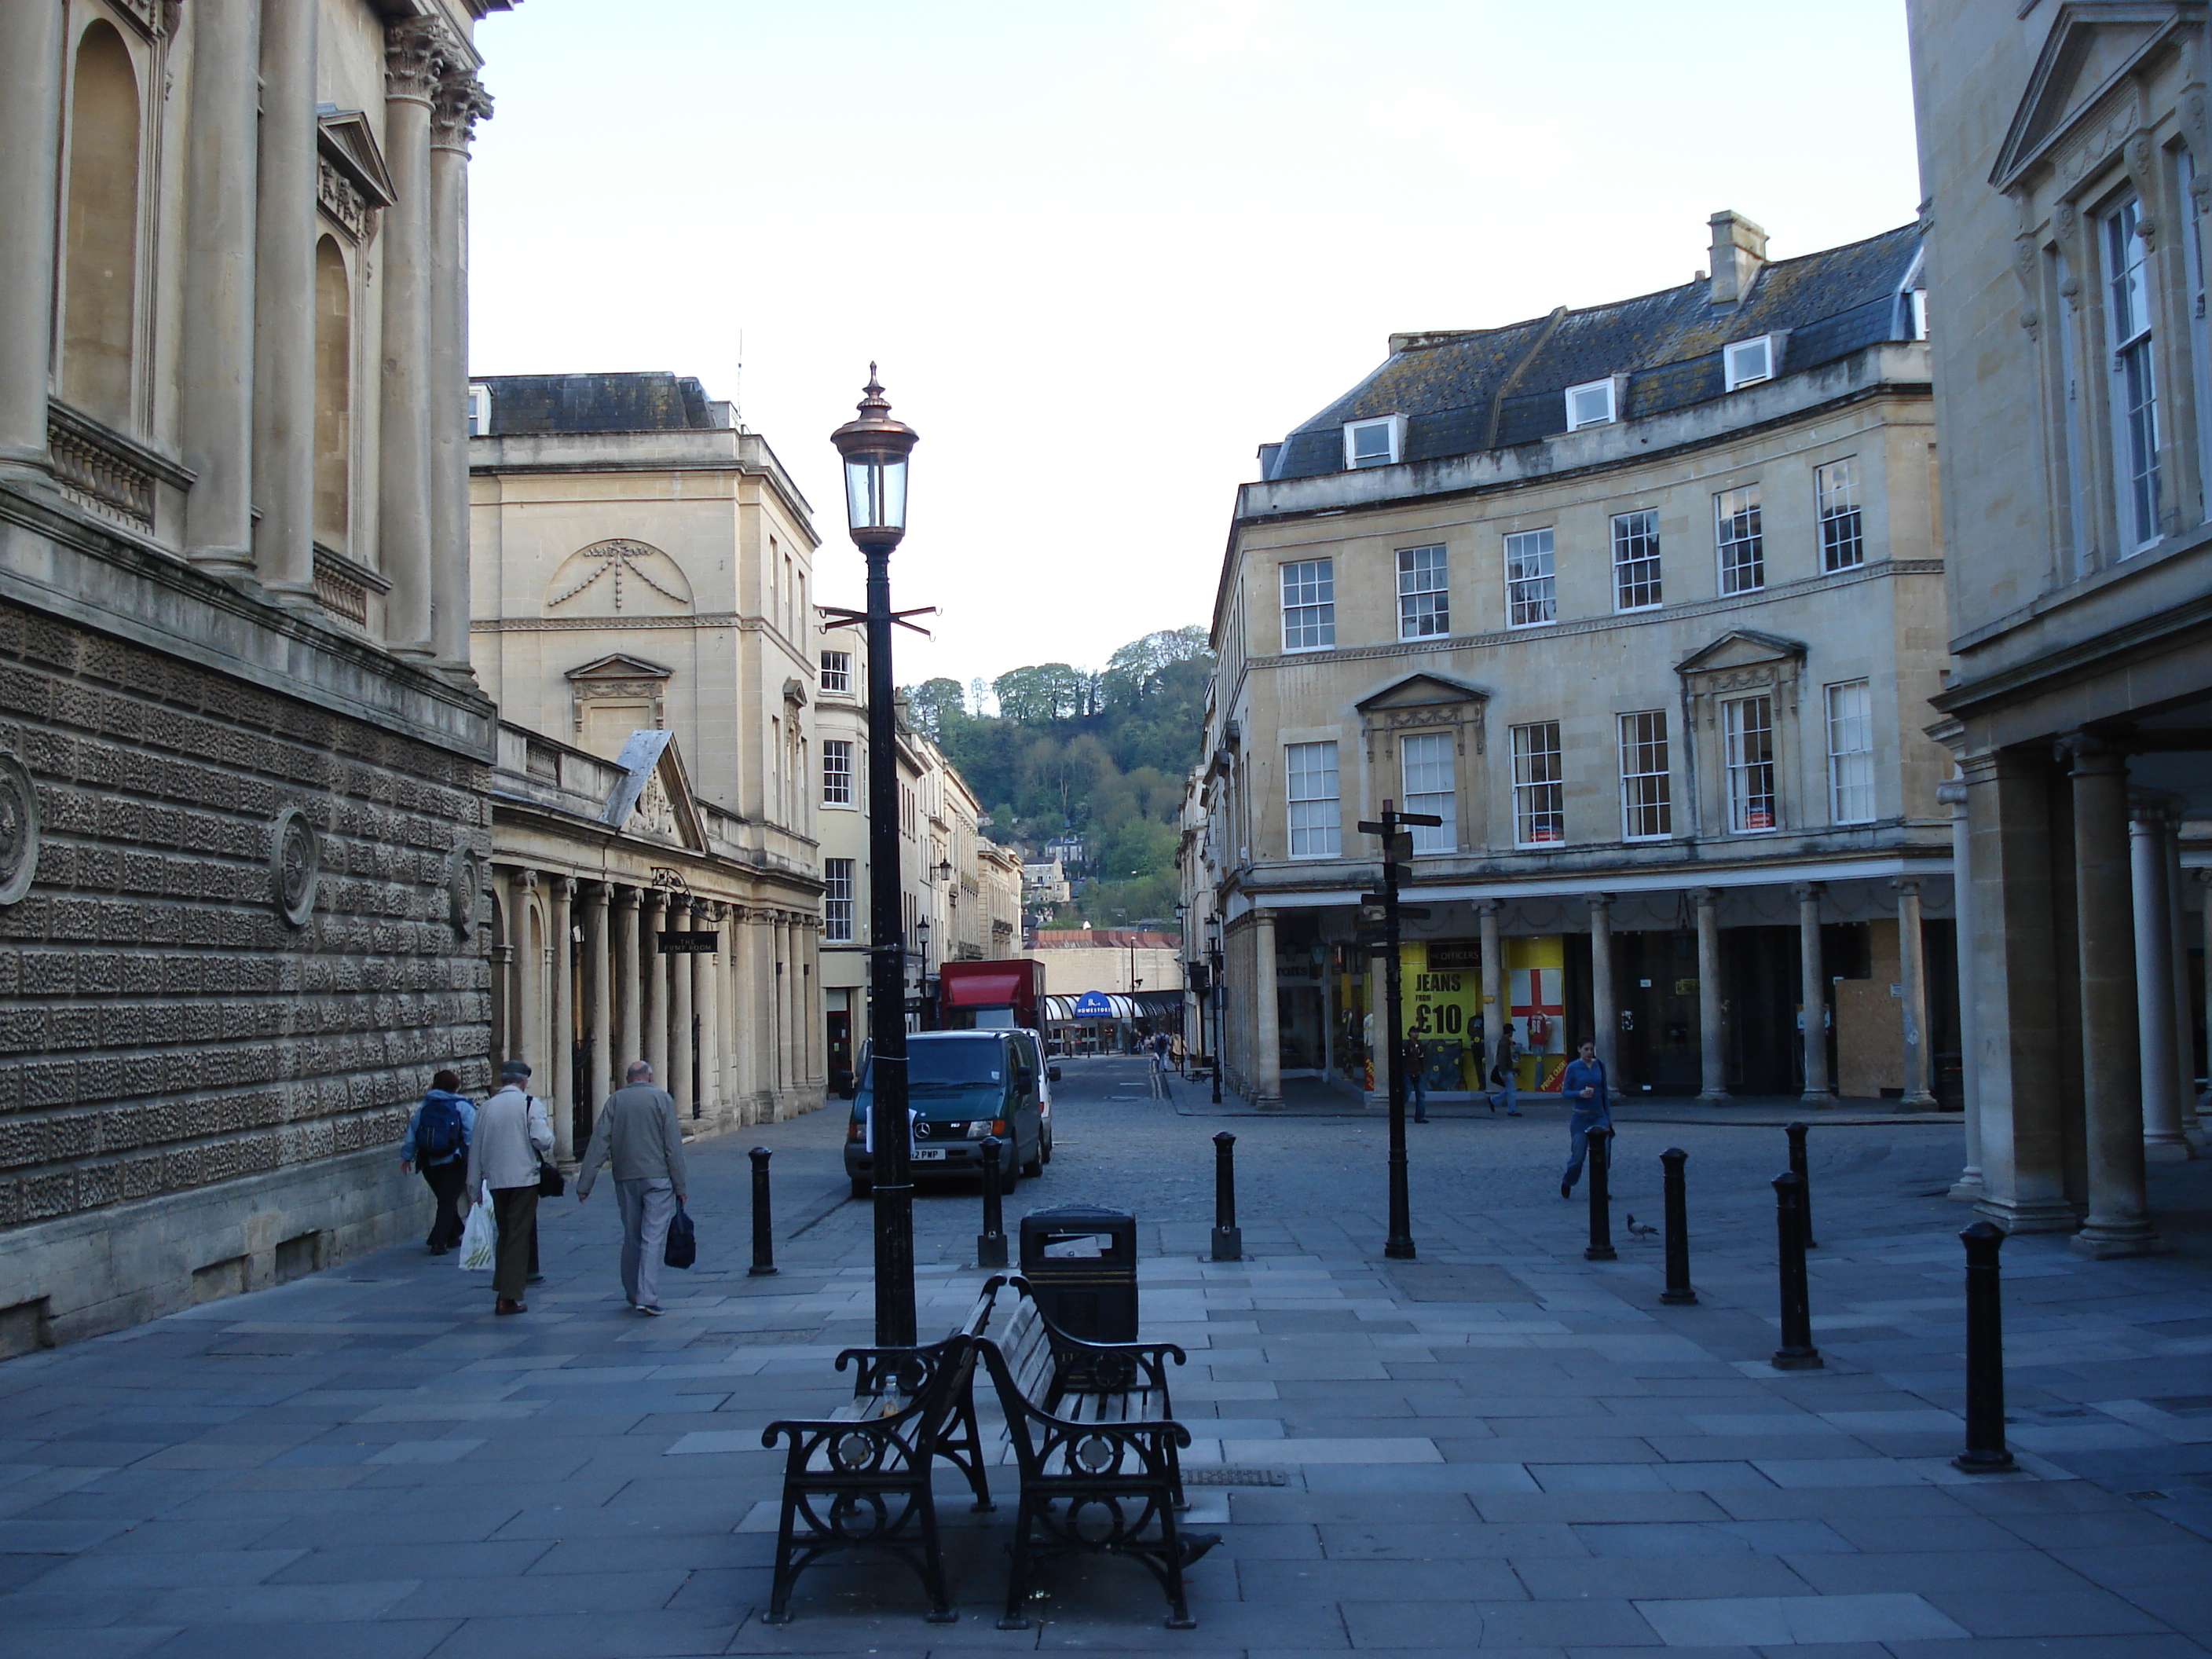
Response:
1960,750,2077,1232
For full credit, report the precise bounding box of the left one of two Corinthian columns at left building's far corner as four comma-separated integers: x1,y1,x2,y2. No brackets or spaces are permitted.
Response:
376,18,445,657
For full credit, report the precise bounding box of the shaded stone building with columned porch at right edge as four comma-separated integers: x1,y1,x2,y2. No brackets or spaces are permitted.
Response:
1909,0,2212,1256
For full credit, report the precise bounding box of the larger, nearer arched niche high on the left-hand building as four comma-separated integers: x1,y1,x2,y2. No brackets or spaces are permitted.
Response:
62,22,139,427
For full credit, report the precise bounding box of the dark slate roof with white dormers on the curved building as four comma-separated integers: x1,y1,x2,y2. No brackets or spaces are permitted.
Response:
1263,223,1920,480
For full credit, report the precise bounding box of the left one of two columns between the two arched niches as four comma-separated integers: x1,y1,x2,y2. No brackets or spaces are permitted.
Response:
179,0,261,575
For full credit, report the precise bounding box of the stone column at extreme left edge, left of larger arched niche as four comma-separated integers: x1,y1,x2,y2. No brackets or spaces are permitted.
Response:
0,5,62,474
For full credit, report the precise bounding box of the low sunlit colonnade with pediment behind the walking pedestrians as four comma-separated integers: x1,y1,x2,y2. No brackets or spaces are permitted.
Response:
491,865,821,1161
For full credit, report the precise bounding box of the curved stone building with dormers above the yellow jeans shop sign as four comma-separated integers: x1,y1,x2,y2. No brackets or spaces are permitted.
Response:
1184,212,1957,1106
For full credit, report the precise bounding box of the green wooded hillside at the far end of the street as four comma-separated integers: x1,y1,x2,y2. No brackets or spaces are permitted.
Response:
905,628,1214,927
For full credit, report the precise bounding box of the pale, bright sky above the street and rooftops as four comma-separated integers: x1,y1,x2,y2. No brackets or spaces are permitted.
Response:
471,0,1917,703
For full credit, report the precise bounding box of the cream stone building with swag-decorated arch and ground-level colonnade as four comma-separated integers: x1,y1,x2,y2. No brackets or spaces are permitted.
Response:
469,374,827,1148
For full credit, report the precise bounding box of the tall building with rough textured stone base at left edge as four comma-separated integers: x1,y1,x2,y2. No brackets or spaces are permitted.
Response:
0,0,507,1352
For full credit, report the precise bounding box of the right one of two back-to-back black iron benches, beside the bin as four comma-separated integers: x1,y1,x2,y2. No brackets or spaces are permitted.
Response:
976,1276,1221,1630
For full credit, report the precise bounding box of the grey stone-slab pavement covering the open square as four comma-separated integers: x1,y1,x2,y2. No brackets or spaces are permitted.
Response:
0,1060,2212,1659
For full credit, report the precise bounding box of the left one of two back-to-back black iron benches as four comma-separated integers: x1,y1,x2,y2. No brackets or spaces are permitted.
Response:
761,1279,1000,1624
